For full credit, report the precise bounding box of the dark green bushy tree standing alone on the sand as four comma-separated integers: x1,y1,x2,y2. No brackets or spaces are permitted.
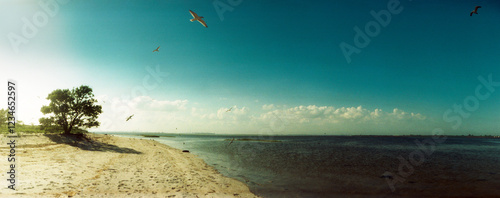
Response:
39,85,102,134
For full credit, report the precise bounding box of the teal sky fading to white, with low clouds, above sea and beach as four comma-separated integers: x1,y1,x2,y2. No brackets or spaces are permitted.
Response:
0,0,500,135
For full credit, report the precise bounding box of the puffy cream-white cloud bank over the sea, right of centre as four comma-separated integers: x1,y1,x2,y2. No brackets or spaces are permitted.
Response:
252,105,428,135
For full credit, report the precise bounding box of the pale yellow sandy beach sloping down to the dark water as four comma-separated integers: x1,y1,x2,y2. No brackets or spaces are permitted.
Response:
0,134,256,197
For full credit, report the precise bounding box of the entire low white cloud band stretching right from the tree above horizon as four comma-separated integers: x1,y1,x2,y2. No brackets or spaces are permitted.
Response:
94,96,427,135
